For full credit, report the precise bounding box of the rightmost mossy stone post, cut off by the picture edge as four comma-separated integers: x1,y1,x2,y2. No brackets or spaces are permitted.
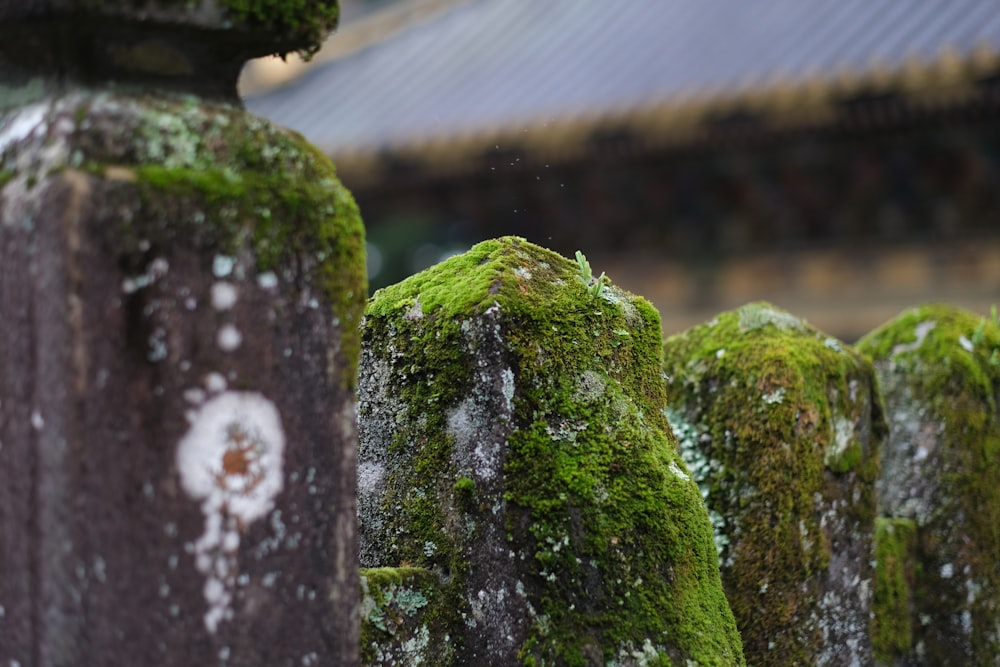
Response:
858,305,1000,665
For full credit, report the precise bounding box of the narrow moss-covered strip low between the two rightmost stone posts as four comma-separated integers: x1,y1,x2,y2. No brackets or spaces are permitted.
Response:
872,518,917,664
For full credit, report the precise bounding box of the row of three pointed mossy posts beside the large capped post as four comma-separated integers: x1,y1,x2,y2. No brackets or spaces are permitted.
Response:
358,237,1000,667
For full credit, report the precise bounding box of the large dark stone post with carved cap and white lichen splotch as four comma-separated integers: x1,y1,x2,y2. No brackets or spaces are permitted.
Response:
0,0,366,667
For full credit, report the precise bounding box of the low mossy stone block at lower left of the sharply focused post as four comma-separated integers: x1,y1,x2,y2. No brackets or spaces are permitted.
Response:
360,567,455,667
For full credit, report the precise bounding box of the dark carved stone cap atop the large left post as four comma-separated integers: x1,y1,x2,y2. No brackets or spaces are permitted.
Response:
0,0,339,106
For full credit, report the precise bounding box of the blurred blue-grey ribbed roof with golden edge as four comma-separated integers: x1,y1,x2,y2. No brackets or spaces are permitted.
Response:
246,0,1000,175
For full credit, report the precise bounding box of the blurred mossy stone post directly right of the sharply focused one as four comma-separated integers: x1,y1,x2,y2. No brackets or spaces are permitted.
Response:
665,303,885,667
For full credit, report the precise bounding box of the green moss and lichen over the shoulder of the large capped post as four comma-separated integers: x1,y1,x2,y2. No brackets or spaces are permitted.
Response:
0,92,367,392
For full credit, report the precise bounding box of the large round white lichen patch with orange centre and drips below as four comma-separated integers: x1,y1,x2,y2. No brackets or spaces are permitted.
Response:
176,392,285,633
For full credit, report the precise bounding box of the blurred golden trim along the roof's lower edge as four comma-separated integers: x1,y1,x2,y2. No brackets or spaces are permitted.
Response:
322,47,1000,183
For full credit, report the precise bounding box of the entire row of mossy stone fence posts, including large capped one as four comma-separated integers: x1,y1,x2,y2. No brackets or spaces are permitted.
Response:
0,0,1000,667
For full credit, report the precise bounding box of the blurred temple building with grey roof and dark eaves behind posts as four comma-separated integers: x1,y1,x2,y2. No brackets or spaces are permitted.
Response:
247,0,1000,339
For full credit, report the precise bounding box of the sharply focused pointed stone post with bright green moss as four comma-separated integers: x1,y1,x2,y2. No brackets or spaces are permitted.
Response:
359,238,743,665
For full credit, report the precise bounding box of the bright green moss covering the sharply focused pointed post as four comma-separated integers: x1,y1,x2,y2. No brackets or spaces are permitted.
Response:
365,237,743,665
